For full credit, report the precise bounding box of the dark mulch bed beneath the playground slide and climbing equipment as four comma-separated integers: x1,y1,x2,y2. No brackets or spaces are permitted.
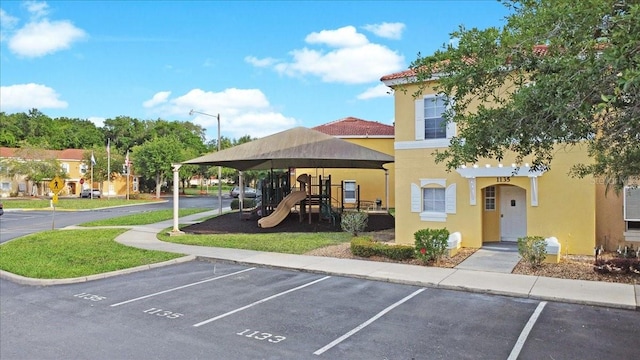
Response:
181,212,395,234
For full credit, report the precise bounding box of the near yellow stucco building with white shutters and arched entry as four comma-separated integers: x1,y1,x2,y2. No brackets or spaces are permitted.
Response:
381,71,640,260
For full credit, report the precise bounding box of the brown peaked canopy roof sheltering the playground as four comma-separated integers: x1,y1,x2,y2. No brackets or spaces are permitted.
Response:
183,127,393,171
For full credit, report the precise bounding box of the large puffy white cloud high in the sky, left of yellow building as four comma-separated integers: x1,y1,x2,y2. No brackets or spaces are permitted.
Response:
250,26,405,84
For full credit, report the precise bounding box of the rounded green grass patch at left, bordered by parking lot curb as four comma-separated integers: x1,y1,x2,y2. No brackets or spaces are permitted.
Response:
0,229,183,279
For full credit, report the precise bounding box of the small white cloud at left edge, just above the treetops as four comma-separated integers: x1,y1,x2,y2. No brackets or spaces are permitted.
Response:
0,83,68,111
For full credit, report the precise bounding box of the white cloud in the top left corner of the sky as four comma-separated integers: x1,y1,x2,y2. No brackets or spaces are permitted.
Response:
0,1,87,58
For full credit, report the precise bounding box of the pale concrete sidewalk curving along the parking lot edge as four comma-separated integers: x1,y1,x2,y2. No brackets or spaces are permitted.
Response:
0,211,640,310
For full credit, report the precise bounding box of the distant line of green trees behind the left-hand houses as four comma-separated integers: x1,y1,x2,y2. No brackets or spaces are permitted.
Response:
0,109,260,196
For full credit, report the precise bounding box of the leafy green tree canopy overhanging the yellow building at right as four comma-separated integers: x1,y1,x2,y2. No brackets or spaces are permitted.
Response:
411,0,640,189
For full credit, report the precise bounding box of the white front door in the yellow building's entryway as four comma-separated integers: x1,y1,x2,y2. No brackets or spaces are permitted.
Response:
499,185,527,241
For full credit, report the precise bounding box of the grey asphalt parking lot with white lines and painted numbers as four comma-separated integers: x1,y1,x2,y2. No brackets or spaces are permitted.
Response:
0,261,640,360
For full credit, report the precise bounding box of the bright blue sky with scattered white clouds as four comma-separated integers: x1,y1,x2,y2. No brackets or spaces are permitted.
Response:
0,0,508,139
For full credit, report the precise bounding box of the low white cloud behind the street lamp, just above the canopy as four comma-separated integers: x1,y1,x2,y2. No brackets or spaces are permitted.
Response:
145,88,297,139
